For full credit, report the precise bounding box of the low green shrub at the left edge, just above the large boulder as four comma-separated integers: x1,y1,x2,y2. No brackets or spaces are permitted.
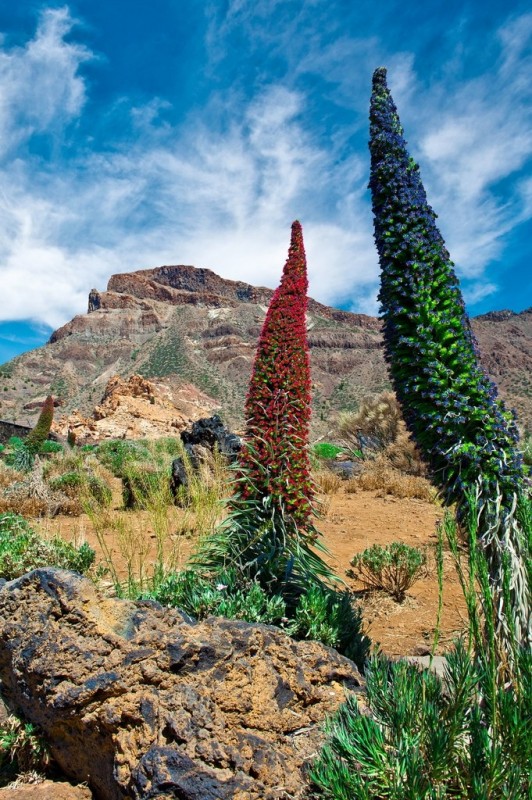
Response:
0,512,95,580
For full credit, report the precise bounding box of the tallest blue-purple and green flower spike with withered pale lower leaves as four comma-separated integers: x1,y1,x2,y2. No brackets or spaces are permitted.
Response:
369,68,530,649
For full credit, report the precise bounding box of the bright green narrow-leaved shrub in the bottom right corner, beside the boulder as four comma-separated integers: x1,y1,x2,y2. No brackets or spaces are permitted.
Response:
311,644,532,800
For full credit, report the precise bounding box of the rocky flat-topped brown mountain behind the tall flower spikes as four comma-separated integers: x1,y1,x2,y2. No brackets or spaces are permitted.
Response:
0,265,532,436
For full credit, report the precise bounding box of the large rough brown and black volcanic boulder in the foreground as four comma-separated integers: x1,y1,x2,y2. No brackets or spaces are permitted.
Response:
0,569,361,800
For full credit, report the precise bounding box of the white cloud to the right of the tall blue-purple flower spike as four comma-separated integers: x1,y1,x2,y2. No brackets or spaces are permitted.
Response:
416,14,532,280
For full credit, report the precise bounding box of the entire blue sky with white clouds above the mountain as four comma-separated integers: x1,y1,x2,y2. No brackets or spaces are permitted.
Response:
0,0,532,362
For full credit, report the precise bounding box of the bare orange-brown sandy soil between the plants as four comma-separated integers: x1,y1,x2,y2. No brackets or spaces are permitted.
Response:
35,490,467,656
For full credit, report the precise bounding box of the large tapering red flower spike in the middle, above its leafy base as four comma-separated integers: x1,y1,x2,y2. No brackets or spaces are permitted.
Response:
240,221,313,530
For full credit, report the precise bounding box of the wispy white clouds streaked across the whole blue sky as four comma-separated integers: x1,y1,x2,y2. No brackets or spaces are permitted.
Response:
0,0,532,336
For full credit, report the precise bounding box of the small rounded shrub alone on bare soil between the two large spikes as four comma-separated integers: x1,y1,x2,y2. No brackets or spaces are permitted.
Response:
347,542,426,602
